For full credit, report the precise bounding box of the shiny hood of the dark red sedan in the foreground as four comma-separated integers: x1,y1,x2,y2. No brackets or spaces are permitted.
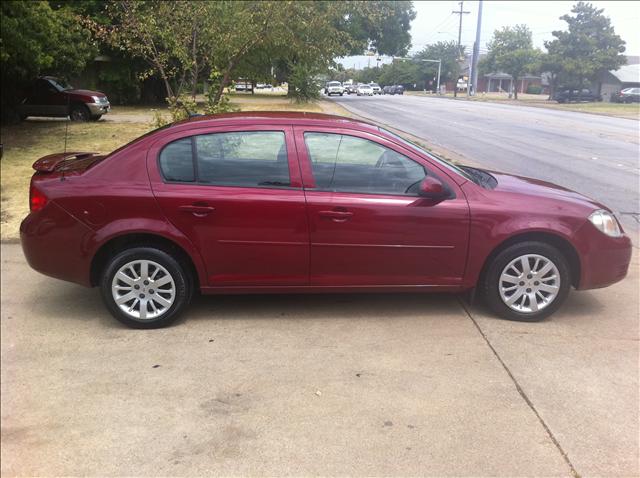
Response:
488,171,608,209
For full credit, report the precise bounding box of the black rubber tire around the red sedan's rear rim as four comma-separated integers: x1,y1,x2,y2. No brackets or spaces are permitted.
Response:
100,247,194,329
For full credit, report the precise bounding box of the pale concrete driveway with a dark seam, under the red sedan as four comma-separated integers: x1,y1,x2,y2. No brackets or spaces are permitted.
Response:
0,244,639,476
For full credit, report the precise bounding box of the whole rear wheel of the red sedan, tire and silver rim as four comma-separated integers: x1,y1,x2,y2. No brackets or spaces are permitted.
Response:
100,247,193,329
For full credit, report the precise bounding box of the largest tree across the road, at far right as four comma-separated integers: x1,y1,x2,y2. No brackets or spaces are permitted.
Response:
545,2,626,94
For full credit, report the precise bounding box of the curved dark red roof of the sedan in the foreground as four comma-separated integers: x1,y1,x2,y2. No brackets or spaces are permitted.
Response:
165,111,380,134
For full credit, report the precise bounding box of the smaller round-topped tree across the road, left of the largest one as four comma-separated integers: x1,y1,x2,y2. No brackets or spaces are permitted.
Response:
486,25,540,99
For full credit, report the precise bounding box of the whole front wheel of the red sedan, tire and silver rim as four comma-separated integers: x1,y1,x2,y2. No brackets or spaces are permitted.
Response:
482,241,571,322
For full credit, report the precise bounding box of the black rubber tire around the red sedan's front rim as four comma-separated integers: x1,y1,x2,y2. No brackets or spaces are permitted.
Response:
480,241,571,322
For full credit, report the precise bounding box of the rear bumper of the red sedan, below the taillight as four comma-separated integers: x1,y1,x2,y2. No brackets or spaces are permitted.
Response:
20,203,94,287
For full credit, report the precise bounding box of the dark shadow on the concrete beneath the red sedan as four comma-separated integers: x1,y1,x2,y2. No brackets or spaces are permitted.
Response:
27,282,604,328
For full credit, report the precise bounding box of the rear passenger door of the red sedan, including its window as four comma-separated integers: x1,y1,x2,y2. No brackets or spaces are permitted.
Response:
147,126,309,287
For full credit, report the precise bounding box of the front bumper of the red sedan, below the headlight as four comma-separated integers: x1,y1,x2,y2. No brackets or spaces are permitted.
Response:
577,224,632,290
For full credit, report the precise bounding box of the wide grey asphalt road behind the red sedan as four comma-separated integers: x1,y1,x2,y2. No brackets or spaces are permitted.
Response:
332,95,640,237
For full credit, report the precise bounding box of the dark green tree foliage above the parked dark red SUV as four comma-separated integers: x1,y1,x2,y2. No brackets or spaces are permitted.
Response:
0,1,97,118
